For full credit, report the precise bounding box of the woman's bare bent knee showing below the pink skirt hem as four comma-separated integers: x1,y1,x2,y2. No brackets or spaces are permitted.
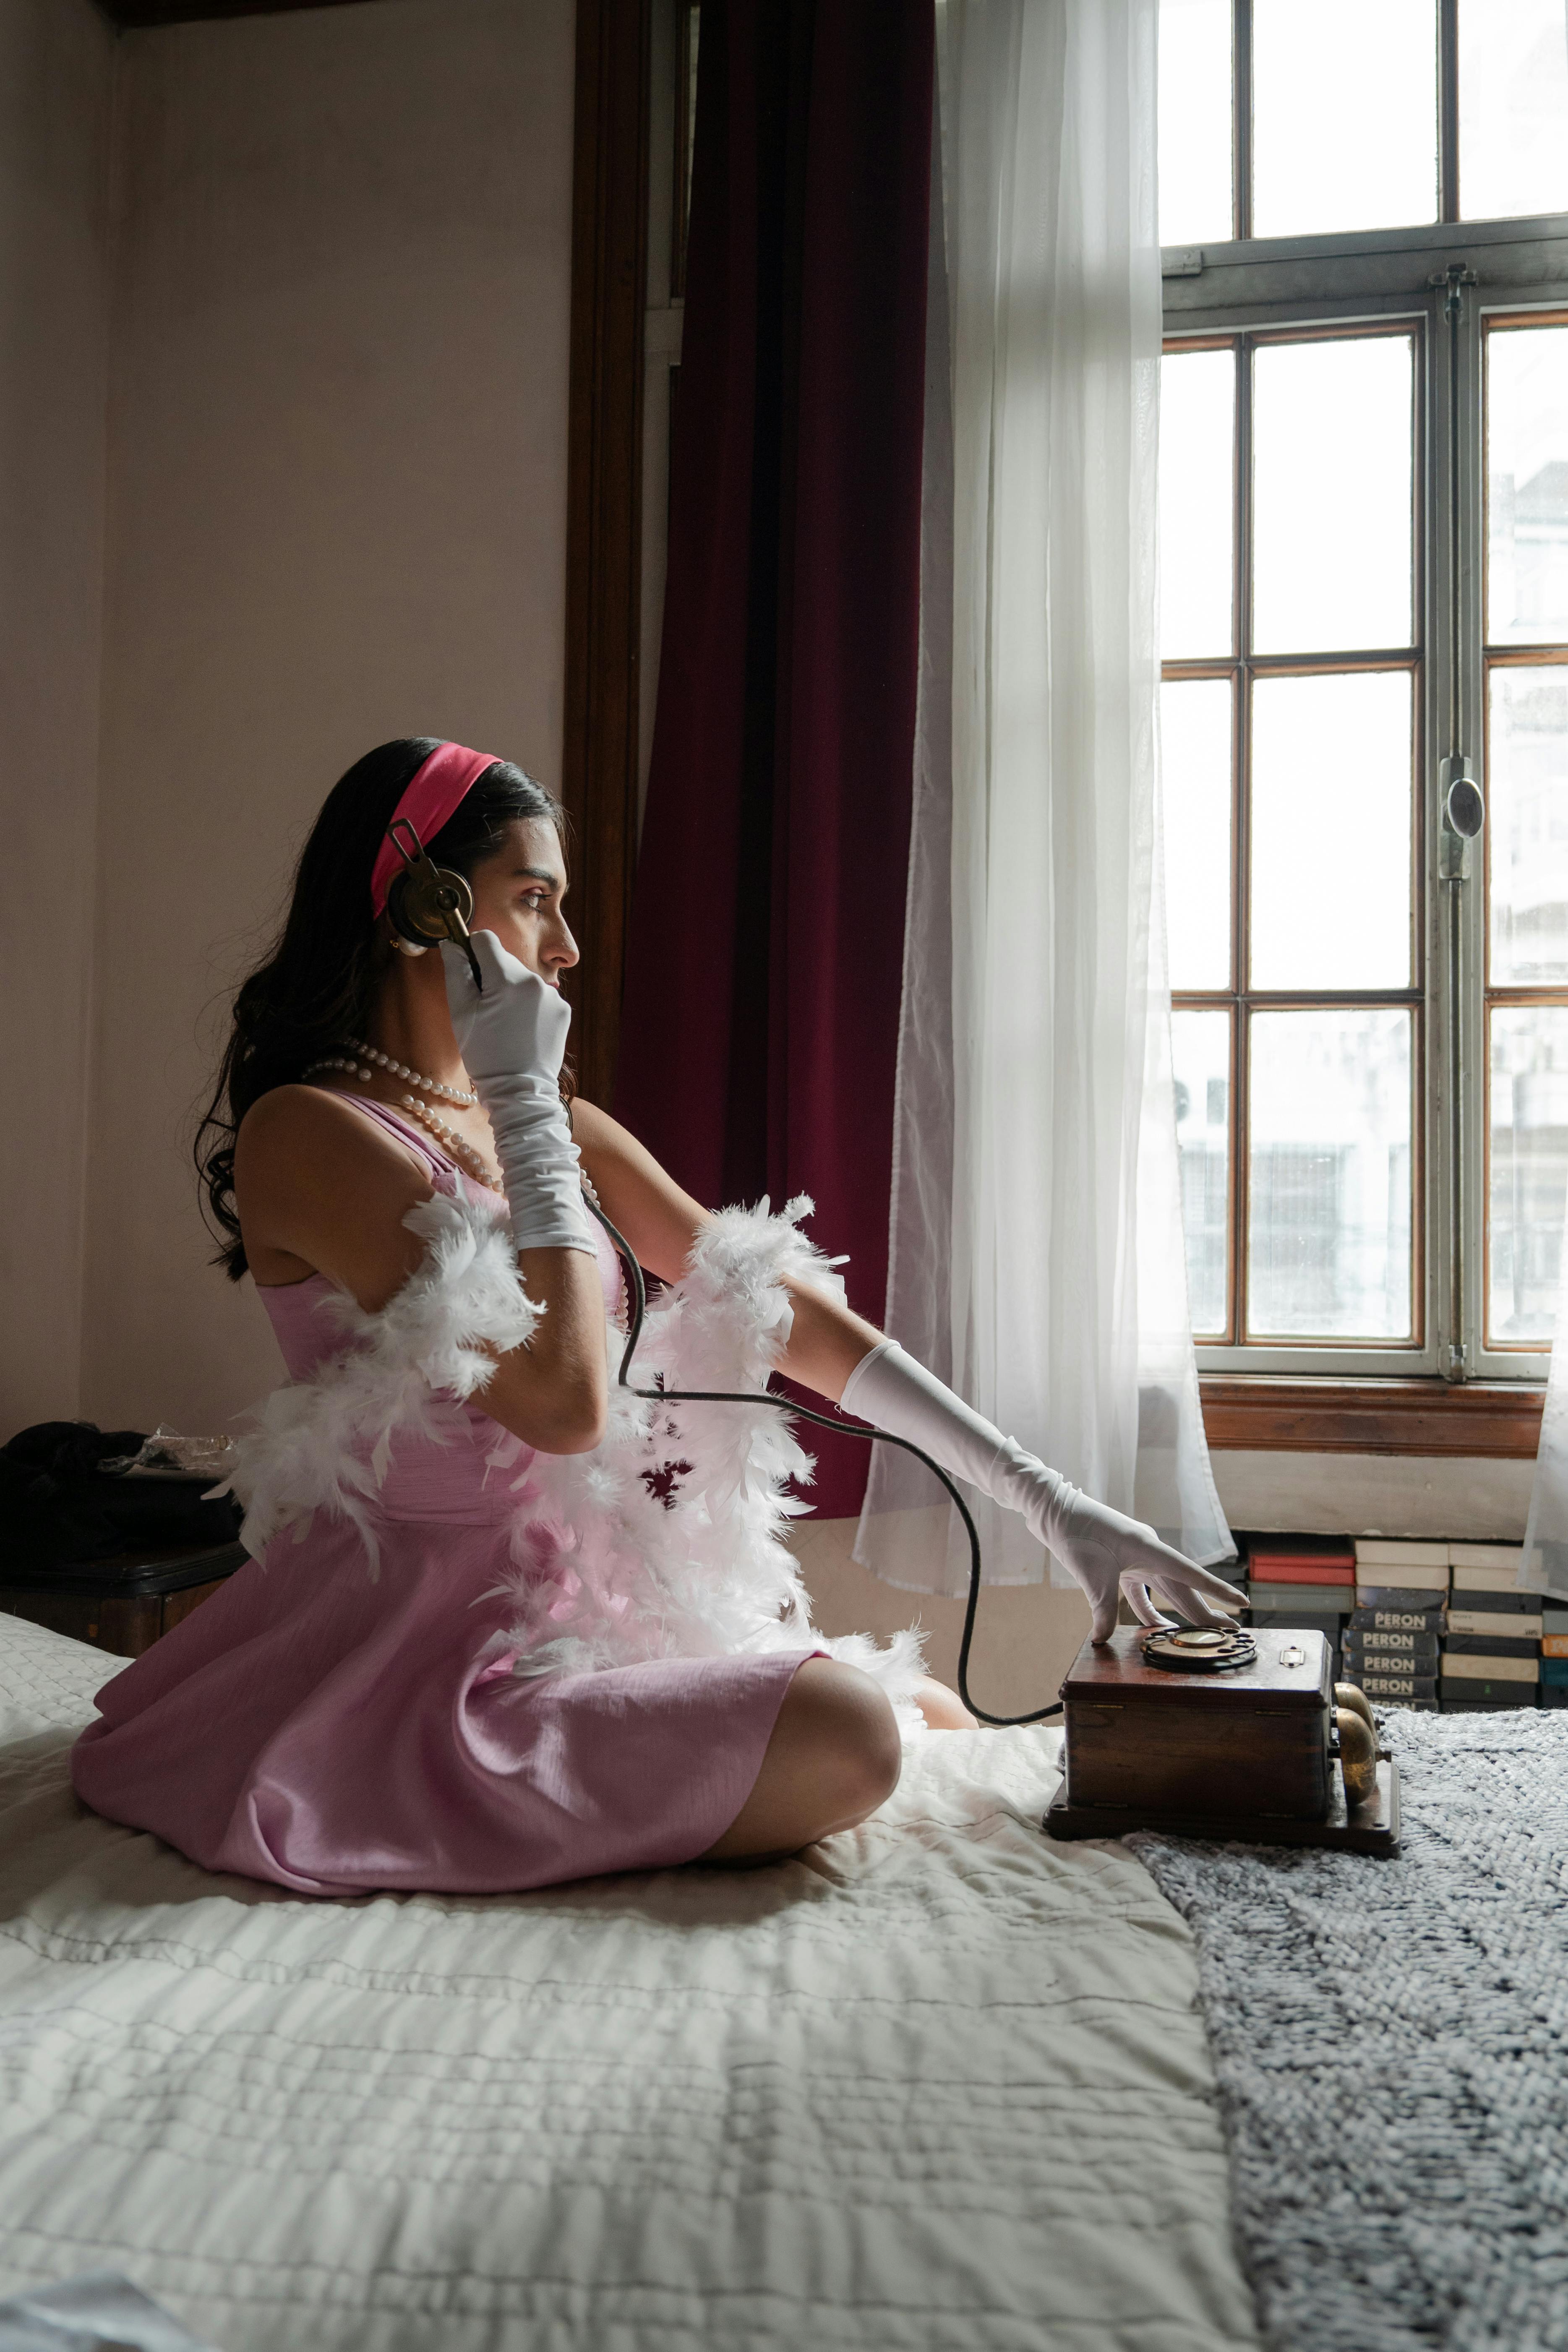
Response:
701,1658,903,1863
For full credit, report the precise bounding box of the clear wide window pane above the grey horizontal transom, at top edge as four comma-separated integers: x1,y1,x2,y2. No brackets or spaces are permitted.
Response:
1253,0,1438,237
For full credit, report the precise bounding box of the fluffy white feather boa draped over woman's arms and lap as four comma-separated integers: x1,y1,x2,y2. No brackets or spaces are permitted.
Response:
233,1192,924,1729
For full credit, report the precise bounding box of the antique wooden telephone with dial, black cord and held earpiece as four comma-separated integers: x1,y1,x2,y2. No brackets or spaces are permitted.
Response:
399,819,1399,1854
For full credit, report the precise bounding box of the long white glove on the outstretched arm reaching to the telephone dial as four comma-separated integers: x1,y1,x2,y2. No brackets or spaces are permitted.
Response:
842,1338,1237,1642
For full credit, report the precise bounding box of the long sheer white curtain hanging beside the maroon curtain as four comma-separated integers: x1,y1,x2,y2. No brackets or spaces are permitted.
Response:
856,0,1232,1592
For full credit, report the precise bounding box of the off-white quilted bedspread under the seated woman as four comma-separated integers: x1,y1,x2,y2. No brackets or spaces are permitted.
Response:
0,1618,1258,2352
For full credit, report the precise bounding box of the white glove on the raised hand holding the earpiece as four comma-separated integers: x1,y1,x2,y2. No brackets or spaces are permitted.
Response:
442,931,595,1256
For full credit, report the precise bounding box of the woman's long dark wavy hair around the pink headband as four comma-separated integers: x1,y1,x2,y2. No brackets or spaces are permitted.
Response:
195,736,566,1282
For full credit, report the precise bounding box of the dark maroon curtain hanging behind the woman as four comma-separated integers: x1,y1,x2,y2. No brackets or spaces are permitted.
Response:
616,0,933,1512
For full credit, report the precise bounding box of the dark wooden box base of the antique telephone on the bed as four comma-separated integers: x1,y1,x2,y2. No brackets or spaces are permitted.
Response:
1046,1625,1399,1854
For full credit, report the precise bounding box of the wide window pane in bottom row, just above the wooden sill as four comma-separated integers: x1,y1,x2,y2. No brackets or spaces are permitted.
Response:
1248,1007,1411,1338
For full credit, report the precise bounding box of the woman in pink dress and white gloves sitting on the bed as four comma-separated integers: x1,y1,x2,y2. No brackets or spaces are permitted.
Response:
73,738,1229,1893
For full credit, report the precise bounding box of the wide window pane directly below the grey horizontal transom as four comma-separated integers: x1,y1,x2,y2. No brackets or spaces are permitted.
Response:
1253,334,1413,654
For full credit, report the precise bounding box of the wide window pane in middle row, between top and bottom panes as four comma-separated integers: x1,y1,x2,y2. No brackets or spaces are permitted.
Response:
1251,670,1413,988
